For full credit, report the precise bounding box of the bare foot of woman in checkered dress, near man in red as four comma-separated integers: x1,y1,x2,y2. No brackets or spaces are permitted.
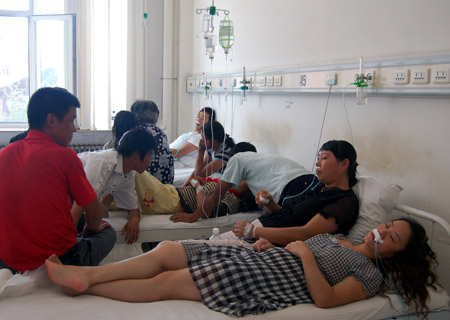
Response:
45,257,89,295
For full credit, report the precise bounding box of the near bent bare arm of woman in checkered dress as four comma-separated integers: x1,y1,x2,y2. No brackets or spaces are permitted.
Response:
286,241,367,308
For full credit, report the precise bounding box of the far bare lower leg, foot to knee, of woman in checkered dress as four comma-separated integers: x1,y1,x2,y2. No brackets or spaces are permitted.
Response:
45,241,187,292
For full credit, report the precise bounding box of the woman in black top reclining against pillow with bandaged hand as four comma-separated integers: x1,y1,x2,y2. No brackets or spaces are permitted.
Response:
232,140,359,245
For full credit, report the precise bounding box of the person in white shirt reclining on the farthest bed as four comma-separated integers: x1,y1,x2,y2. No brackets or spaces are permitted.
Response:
169,107,215,170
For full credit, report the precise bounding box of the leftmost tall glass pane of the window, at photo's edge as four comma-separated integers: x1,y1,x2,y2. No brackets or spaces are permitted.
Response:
0,16,29,122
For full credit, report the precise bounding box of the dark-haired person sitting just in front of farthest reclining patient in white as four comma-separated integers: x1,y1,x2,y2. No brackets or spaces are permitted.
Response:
184,121,234,185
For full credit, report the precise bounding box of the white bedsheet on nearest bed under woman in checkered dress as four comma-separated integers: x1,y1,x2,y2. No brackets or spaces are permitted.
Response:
0,272,449,320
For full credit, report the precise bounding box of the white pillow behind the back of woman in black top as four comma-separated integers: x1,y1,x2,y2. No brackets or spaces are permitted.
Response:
347,177,403,243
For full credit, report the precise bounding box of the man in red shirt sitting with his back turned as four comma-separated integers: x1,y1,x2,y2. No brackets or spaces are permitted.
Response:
0,88,116,272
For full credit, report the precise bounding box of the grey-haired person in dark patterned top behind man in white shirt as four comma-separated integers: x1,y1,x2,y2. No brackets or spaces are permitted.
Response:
131,100,174,184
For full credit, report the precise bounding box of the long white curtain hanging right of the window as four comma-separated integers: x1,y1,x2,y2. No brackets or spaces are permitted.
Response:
77,0,173,135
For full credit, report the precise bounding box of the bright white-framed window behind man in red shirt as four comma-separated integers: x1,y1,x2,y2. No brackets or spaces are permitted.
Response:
0,0,76,127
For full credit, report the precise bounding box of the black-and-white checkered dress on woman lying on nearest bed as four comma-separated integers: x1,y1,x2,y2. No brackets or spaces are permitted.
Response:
183,235,382,317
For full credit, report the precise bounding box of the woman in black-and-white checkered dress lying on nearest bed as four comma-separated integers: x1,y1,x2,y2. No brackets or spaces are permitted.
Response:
46,219,436,316
